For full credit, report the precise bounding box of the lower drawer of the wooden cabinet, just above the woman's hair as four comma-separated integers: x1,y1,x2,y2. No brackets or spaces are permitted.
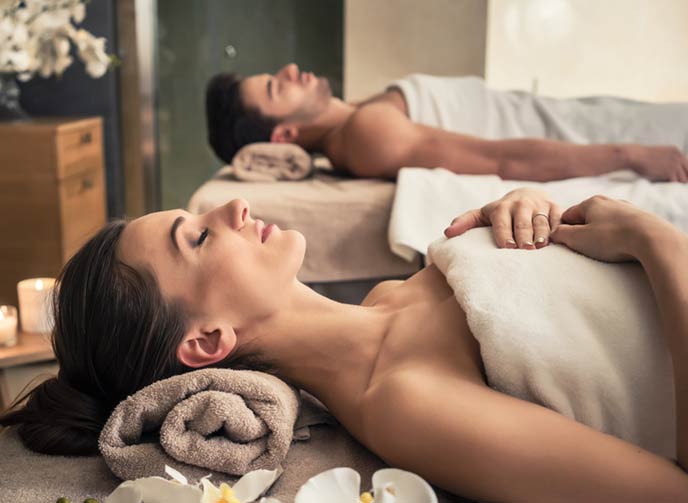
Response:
58,167,106,250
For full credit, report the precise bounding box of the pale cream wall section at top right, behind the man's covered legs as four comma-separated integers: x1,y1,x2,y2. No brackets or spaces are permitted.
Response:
485,0,688,101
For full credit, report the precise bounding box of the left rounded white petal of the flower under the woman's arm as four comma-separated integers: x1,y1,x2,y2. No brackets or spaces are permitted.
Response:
294,468,361,503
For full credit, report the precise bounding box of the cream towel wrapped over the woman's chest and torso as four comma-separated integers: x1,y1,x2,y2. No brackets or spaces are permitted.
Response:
429,228,676,458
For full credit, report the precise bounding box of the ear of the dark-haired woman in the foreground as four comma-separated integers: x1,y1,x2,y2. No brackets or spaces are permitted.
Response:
177,325,237,368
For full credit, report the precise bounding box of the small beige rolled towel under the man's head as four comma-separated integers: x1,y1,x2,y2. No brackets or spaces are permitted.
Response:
231,142,313,182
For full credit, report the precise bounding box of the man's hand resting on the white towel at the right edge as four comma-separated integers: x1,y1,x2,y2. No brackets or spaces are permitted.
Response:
626,145,688,183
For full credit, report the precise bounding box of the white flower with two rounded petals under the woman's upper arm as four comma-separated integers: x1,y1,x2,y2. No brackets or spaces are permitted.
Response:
294,468,437,503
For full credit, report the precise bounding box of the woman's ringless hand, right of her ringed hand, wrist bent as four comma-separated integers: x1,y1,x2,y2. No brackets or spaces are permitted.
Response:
550,196,679,262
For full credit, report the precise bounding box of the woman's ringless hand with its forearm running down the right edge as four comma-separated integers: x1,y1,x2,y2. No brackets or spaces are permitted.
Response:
552,196,688,471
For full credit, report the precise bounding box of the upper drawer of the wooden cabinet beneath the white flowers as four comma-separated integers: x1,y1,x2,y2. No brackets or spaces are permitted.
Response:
56,121,103,179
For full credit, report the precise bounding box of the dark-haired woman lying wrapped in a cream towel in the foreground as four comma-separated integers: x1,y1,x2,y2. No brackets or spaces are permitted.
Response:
0,189,688,503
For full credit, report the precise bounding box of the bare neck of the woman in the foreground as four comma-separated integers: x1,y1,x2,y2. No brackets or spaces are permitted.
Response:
240,281,398,406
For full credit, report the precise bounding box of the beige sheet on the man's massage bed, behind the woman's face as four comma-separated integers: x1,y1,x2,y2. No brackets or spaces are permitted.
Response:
188,169,420,282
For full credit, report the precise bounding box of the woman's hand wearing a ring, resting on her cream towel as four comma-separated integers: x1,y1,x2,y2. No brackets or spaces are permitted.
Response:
444,188,561,250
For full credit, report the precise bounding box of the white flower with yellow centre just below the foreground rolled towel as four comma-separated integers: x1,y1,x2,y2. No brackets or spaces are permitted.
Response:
105,466,280,503
